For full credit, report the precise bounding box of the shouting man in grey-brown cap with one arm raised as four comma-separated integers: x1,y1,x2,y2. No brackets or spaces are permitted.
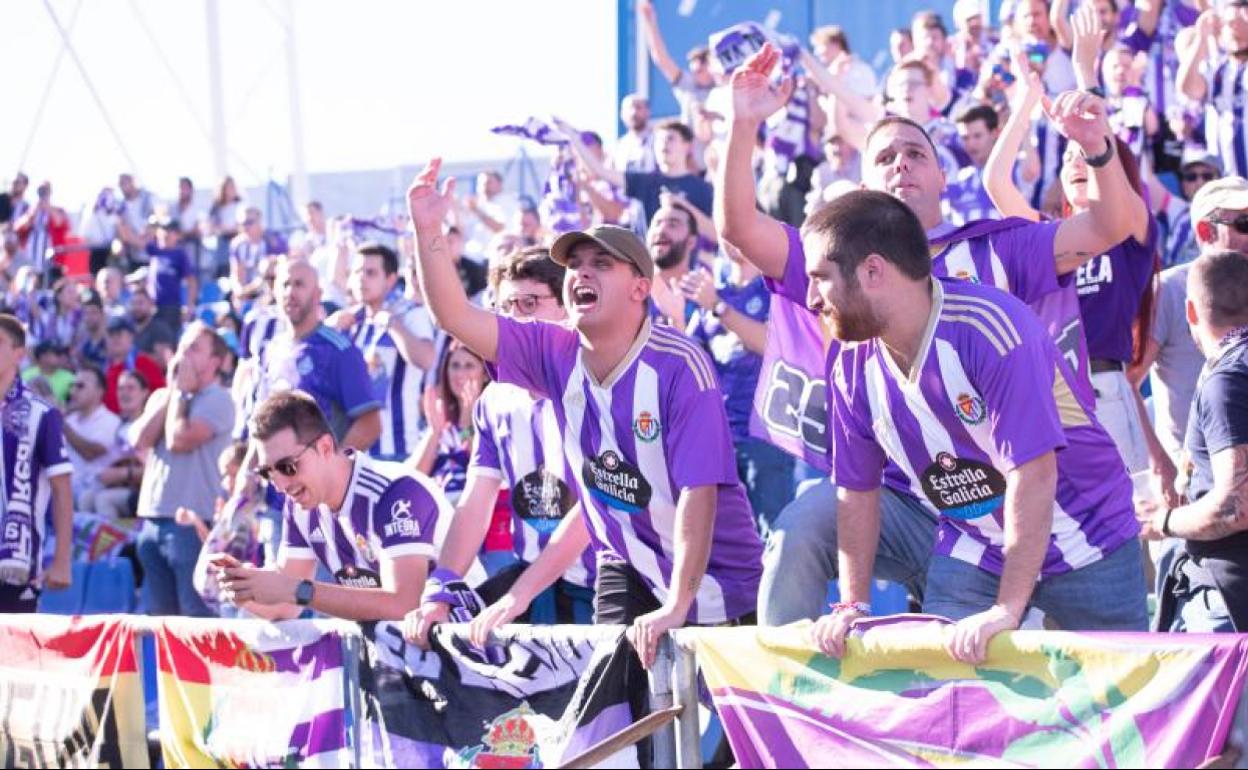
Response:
408,160,763,668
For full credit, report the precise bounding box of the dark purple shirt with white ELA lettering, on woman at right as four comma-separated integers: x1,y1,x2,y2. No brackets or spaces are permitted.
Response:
1075,216,1157,363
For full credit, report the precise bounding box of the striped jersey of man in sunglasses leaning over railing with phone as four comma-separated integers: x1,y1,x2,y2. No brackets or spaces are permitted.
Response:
277,451,452,588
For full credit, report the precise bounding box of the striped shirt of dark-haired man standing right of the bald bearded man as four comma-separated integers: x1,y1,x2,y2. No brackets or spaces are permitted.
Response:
348,300,433,461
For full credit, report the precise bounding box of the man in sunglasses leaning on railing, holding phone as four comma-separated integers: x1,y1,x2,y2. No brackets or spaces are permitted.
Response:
213,391,451,620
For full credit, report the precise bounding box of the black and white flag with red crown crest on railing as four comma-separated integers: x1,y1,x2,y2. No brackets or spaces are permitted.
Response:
363,623,641,768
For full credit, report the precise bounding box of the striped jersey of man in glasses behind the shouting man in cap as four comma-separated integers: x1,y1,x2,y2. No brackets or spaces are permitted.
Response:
468,382,594,588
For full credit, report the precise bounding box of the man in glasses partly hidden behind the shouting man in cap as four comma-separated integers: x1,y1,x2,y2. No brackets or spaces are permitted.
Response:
404,246,594,645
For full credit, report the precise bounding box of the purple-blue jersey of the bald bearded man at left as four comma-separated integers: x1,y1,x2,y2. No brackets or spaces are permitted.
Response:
256,324,381,442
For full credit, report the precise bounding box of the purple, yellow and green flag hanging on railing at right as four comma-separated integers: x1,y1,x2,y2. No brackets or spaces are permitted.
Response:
681,616,1248,768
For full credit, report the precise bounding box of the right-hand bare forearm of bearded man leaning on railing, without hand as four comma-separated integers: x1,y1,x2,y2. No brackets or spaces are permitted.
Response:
997,452,1057,620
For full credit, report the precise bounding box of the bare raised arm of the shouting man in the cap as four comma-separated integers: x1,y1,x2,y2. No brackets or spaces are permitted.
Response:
407,157,498,362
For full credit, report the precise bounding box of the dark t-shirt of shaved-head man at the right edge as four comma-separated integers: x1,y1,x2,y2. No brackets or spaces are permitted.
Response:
1184,336,1248,631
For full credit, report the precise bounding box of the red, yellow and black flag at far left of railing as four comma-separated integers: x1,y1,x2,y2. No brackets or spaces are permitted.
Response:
0,615,150,768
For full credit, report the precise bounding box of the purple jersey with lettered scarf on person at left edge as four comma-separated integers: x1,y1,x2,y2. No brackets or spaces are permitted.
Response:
0,377,72,585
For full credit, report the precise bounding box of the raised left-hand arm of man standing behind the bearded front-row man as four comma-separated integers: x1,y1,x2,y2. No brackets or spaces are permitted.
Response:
715,44,794,278
